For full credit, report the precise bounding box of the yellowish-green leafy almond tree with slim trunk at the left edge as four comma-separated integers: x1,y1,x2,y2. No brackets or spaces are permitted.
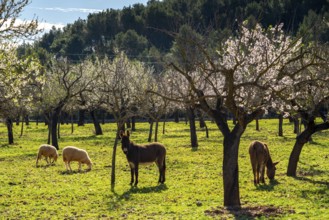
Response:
0,43,40,144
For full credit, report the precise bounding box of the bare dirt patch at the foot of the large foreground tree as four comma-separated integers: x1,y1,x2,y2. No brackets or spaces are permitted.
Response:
205,206,295,219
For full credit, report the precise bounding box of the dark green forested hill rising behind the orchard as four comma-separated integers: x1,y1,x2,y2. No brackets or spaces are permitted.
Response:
29,0,329,61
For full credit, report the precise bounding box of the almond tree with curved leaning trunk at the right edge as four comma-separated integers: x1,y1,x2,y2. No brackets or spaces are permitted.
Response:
279,45,329,176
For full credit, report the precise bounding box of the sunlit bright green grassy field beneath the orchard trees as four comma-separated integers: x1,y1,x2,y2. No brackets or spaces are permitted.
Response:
0,120,329,219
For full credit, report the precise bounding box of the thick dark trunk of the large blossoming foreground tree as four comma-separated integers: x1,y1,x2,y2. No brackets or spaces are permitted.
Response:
223,125,244,208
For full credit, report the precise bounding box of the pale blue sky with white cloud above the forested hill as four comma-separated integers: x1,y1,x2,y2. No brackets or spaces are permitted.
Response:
20,0,148,32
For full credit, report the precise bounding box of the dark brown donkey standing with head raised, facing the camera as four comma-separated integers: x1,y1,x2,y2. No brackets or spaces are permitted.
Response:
120,131,166,186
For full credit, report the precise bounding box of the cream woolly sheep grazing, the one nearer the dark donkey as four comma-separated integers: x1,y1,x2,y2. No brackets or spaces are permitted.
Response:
63,146,92,171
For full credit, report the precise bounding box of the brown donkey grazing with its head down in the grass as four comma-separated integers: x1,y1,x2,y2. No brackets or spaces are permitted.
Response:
249,141,279,185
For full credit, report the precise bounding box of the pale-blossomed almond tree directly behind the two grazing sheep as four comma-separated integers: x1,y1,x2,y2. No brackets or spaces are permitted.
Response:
38,58,96,149
